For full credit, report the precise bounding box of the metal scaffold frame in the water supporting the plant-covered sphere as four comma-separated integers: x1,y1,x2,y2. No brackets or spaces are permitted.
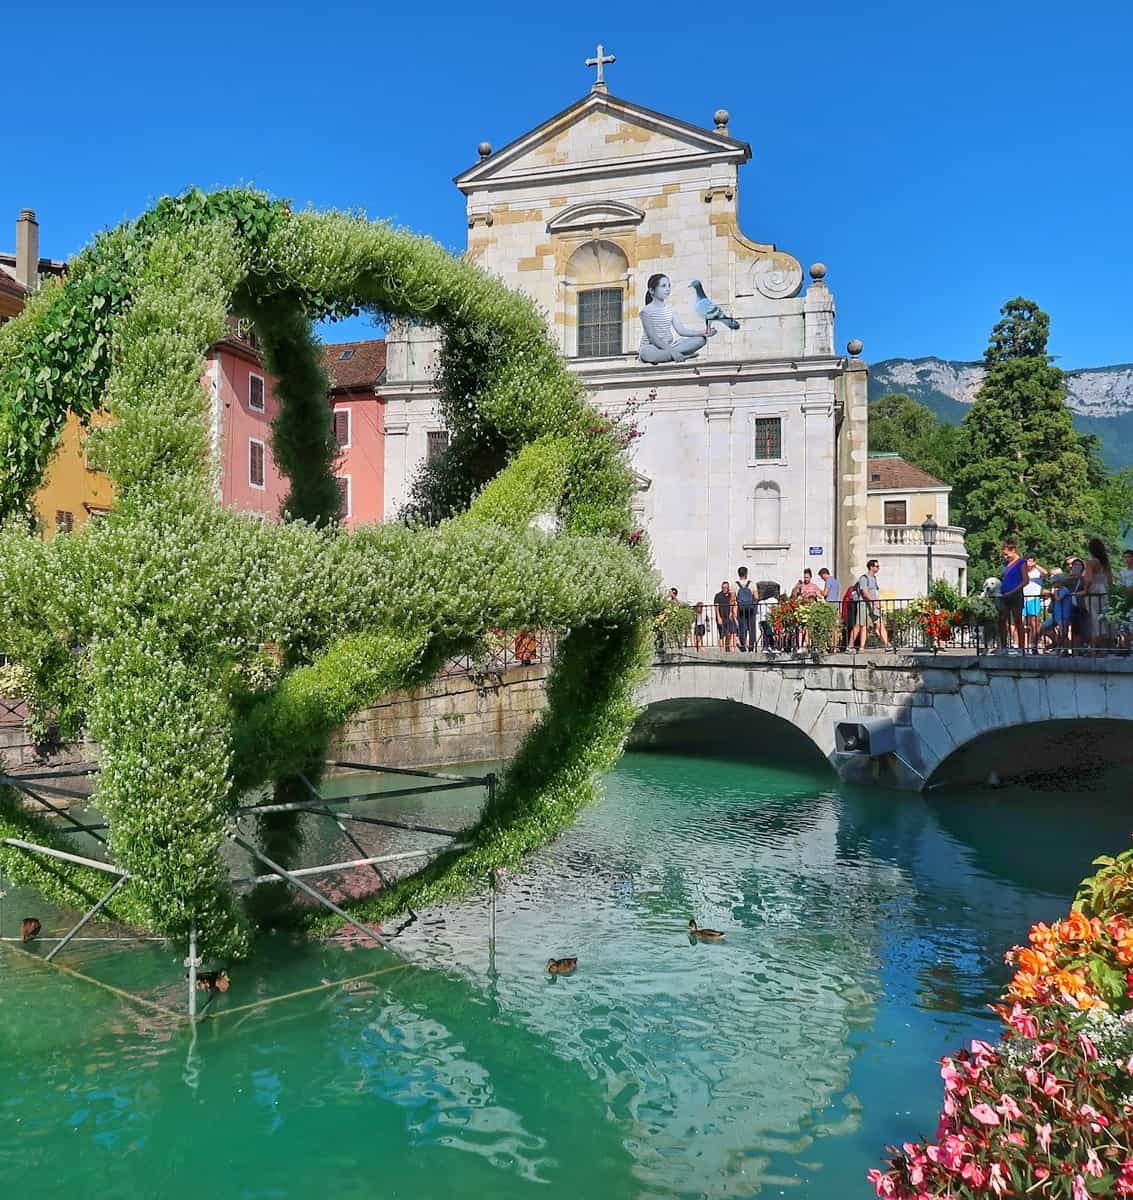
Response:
0,761,497,1025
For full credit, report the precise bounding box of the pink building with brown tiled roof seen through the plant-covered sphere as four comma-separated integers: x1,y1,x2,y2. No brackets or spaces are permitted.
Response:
203,323,385,526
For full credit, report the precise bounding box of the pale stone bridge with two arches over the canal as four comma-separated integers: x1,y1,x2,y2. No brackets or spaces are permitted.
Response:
636,653,1133,790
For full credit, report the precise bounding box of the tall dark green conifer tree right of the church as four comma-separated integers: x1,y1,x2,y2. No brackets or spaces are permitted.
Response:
952,298,1097,582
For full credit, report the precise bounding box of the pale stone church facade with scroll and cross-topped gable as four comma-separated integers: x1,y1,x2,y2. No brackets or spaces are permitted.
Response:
382,72,867,600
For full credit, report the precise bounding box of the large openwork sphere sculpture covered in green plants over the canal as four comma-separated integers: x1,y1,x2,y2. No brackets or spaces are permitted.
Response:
0,191,657,955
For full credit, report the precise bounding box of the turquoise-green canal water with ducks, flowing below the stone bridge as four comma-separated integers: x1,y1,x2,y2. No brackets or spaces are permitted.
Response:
0,755,1128,1200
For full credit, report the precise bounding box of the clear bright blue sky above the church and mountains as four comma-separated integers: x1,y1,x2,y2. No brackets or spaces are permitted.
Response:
8,0,1133,367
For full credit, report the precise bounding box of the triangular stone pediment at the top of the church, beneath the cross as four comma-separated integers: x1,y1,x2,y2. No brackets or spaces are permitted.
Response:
455,91,751,194
